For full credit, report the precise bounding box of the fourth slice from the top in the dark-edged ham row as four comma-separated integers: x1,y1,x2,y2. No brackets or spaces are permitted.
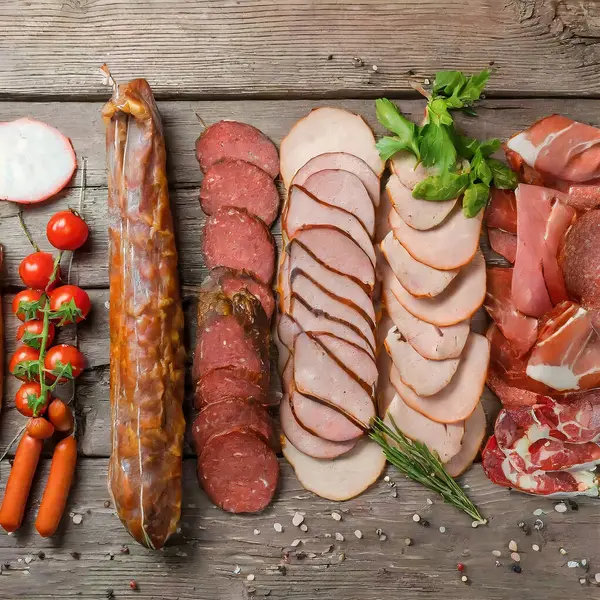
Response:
282,185,376,265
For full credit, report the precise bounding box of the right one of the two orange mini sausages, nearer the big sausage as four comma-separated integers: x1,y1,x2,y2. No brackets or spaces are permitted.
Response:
35,436,77,537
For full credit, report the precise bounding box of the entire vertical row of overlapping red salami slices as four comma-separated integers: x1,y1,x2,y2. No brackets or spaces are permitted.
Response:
192,121,279,513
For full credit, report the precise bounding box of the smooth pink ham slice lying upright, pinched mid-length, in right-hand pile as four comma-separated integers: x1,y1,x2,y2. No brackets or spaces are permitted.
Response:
512,184,575,317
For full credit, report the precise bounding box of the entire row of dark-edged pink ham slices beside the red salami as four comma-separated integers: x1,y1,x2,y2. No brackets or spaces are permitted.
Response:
274,107,385,500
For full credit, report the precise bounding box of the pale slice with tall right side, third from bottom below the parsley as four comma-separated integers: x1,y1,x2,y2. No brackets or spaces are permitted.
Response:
390,333,489,423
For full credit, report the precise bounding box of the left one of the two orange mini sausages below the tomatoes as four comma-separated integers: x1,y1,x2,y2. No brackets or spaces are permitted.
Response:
0,433,44,533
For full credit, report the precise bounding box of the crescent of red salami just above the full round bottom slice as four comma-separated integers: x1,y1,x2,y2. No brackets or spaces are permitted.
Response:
192,399,277,454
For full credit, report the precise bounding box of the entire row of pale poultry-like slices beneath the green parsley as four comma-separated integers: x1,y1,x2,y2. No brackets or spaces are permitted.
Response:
378,153,489,476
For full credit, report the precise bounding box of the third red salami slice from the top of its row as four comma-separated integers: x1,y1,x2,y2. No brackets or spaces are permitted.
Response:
202,207,275,283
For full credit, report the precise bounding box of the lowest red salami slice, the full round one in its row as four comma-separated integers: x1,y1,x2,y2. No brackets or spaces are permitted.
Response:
198,431,279,513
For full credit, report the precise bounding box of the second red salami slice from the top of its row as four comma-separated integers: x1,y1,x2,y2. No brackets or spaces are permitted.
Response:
200,160,279,227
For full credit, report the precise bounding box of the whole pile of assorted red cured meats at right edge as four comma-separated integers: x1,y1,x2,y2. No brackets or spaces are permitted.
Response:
483,115,600,497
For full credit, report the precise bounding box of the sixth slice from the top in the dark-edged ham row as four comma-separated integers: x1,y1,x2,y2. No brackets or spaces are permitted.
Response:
278,238,375,327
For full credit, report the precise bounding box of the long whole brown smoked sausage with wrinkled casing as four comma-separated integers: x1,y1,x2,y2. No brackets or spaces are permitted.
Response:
102,79,185,549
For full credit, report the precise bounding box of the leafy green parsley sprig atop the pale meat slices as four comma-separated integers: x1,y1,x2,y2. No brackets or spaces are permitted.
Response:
375,69,517,217
